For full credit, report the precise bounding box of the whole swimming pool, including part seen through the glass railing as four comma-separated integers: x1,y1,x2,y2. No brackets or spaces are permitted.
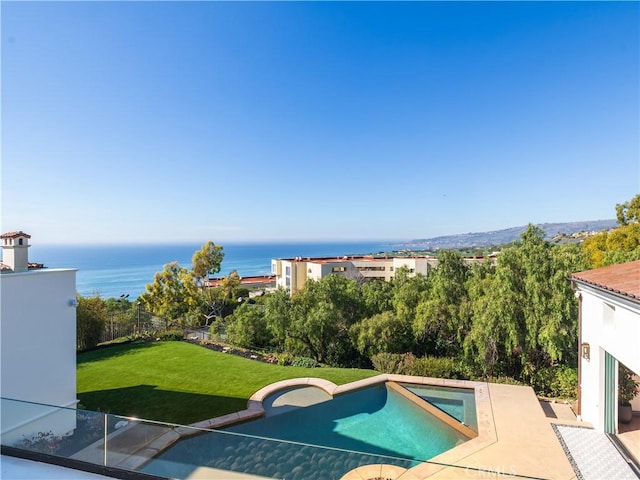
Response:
142,383,476,479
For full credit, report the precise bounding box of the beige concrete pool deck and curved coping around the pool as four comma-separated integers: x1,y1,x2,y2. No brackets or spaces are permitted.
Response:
250,375,590,480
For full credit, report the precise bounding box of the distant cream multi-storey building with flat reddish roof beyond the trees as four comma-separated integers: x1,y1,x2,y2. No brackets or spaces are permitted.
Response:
271,256,438,295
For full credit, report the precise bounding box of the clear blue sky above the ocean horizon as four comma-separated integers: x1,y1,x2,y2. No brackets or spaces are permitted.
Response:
1,1,640,244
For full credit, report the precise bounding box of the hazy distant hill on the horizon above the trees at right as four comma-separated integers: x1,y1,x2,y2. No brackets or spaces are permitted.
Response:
402,220,617,250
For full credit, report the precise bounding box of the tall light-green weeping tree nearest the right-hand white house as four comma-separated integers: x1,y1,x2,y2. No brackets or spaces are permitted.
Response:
465,225,581,379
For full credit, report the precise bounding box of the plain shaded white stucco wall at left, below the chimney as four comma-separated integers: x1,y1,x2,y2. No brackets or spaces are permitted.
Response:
0,269,76,406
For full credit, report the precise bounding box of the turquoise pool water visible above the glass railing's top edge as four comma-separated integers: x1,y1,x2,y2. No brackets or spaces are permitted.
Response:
225,384,467,460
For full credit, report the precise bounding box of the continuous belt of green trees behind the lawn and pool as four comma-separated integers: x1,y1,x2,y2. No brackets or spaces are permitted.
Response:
130,196,640,398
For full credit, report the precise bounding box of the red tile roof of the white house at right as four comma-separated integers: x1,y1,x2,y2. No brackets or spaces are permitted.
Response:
571,260,640,300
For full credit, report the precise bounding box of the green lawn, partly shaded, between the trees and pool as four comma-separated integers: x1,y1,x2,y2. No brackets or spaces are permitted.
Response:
77,342,377,424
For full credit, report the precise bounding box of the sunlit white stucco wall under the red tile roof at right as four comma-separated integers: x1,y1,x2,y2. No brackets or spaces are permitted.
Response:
577,285,640,430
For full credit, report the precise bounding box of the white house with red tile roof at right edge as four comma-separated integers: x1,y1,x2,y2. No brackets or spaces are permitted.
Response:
571,261,640,434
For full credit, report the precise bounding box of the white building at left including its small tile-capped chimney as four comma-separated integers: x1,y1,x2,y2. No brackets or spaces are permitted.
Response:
0,232,77,443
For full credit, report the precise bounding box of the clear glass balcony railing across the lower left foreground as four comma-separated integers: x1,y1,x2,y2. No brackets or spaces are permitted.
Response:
1,398,418,480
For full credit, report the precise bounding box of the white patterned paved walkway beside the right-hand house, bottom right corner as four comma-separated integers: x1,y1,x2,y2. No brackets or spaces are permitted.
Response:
554,425,638,480
